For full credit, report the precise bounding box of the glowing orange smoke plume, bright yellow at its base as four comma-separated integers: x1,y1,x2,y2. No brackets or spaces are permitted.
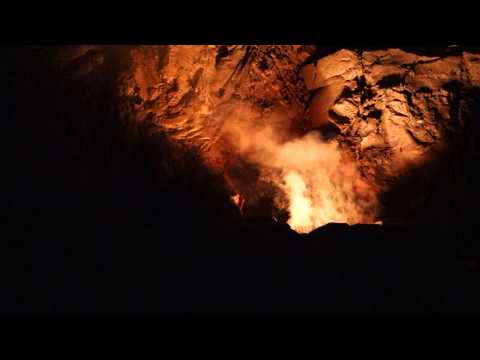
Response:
219,108,377,232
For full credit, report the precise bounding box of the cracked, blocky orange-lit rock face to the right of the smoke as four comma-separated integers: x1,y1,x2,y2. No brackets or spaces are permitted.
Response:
302,49,480,221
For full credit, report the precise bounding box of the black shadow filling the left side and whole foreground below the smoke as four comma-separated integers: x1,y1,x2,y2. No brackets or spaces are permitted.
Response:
0,48,480,317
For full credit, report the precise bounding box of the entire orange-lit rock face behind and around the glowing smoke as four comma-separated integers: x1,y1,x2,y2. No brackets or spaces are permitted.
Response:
50,45,480,225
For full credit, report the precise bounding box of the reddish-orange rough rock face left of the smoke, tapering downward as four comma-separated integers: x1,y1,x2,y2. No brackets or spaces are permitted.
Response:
119,46,311,217
